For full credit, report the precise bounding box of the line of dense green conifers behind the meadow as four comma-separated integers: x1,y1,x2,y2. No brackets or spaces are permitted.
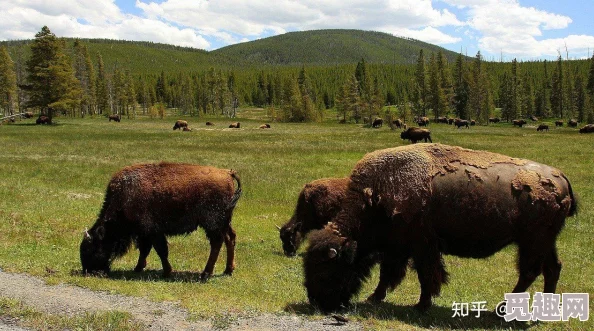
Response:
0,26,594,123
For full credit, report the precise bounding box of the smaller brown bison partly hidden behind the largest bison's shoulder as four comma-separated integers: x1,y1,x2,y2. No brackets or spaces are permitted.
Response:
279,178,349,256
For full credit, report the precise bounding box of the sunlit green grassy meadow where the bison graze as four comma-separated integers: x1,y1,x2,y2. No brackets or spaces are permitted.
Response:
0,111,594,330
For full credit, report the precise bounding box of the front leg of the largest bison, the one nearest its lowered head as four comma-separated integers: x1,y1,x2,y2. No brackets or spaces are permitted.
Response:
367,256,408,303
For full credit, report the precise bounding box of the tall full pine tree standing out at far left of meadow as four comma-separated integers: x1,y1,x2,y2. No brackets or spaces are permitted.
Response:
27,26,82,122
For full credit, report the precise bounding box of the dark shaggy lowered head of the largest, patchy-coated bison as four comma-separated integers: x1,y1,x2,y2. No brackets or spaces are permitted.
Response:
303,227,360,312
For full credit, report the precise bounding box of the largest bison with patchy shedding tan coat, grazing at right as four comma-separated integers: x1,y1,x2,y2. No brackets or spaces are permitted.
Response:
303,144,576,312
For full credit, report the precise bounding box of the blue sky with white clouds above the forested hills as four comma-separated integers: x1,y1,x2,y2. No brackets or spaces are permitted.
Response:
0,0,594,61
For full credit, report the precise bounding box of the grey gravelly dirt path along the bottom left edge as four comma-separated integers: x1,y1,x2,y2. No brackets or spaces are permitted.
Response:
0,271,362,331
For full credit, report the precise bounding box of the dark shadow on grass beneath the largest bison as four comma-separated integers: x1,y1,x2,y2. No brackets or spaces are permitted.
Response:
285,302,535,330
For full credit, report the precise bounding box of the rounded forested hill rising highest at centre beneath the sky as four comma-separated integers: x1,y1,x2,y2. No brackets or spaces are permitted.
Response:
211,30,457,65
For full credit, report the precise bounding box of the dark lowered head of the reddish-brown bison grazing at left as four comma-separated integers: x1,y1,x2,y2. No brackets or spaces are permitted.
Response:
80,226,111,274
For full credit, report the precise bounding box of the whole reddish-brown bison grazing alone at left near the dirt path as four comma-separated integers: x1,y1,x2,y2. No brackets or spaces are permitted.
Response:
80,163,241,280
